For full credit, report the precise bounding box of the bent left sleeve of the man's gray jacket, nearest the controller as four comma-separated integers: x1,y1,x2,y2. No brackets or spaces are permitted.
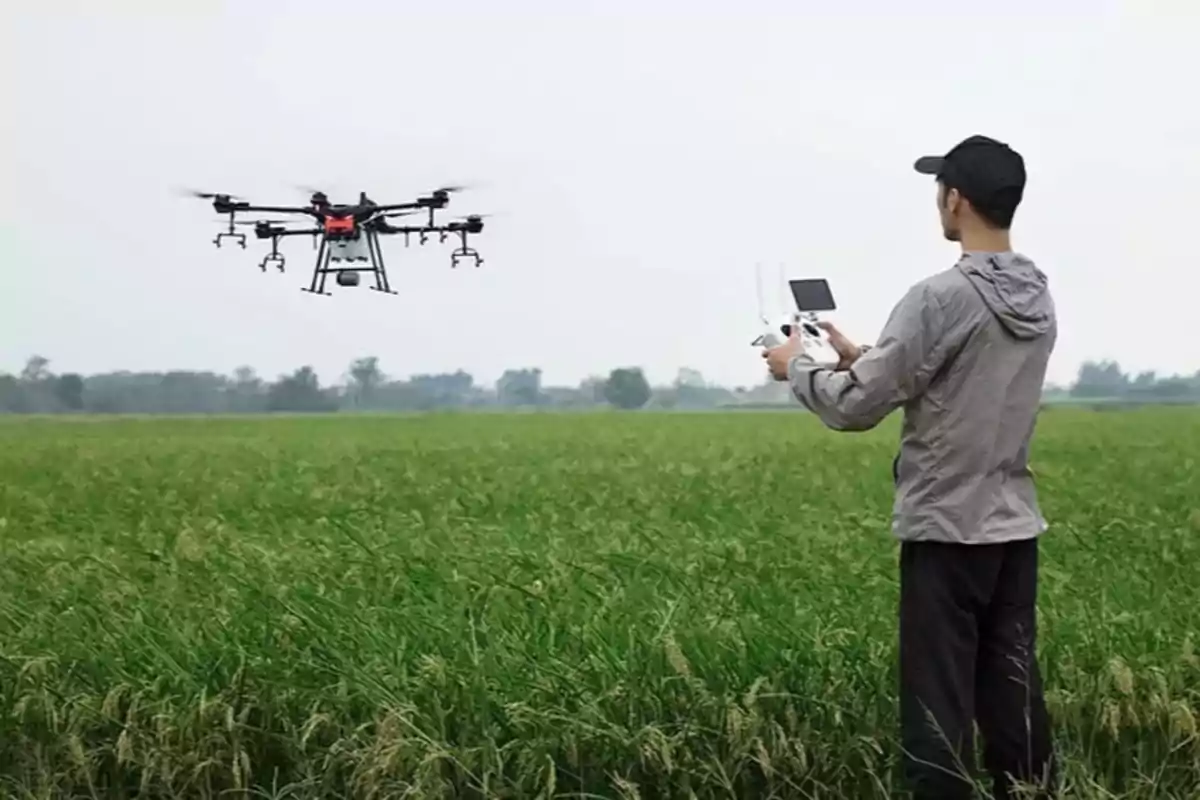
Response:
787,284,946,431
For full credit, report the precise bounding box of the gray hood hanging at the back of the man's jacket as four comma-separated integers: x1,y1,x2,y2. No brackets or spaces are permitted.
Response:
958,252,1054,339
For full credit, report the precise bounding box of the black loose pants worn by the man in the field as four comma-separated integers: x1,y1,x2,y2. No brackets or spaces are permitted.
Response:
900,539,1057,800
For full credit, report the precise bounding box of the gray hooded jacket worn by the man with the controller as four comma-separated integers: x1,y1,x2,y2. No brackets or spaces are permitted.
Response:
788,252,1057,543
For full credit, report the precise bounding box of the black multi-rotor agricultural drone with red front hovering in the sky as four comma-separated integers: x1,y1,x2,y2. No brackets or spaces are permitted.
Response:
187,186,487,295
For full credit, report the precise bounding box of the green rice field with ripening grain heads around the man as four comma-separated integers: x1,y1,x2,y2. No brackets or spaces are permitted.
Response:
0,408,1200,800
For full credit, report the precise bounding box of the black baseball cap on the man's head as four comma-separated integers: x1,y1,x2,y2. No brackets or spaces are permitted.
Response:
913,136,1025,217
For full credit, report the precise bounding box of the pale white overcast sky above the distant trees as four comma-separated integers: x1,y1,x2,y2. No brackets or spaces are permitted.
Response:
0,0,1200,385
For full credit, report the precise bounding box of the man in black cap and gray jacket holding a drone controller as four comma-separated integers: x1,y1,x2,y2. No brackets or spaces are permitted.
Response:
763,136,1057,799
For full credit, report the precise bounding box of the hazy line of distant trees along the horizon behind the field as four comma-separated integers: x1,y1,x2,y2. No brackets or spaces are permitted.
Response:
0,355,1200,414
